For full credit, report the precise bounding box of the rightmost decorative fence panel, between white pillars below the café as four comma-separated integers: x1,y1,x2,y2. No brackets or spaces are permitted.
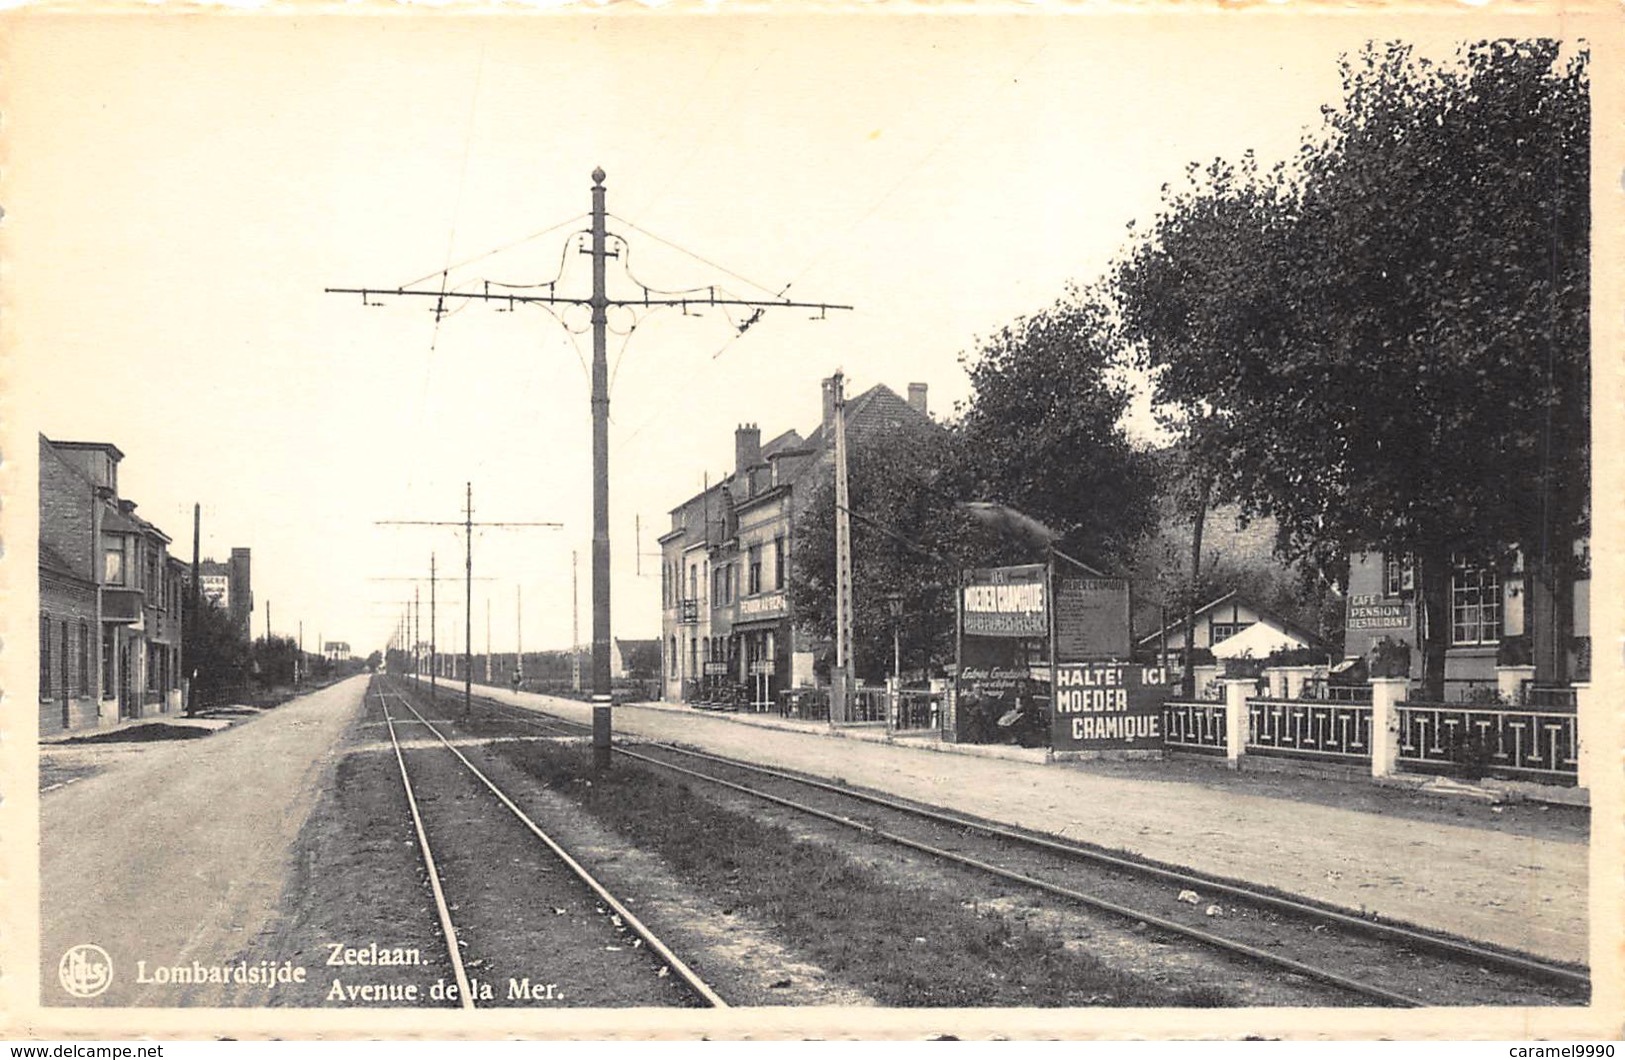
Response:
1399,702,1580,782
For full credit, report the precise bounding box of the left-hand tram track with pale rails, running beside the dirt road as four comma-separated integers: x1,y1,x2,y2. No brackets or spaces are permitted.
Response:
366,681,728,1008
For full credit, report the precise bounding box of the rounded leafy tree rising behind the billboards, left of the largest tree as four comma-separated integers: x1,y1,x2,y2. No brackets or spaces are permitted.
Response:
957,288,1154,567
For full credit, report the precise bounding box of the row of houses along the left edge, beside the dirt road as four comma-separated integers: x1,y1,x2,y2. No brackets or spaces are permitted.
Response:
39,434,254,735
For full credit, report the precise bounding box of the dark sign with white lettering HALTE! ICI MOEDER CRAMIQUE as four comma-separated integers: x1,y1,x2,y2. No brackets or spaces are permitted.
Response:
1051,662,1172,751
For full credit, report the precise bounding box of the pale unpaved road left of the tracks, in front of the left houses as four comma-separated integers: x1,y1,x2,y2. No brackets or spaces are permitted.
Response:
41,675,367,1006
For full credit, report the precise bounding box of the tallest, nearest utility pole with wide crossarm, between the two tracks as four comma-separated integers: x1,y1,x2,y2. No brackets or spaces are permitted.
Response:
327,167,852,769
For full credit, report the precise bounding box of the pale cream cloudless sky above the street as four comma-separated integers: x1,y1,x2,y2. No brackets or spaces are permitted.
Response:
0,8,1599,654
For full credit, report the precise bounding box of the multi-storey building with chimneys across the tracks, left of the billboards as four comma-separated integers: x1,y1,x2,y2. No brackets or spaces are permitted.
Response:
660,379,933,704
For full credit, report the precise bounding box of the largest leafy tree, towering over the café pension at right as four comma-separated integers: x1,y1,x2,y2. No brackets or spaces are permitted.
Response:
1115,41,1589,696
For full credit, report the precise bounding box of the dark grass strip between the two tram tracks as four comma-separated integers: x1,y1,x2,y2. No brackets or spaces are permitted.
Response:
496,731,1229,1008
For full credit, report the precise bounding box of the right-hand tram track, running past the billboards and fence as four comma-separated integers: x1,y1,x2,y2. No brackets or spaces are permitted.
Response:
412,679,1591,1006
